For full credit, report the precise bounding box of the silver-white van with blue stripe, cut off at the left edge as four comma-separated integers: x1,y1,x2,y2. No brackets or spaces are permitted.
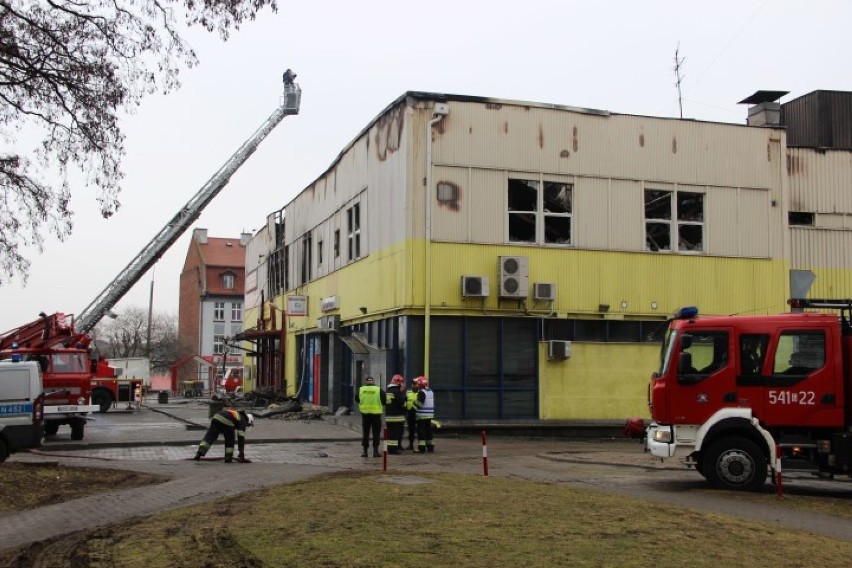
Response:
0,361,44,462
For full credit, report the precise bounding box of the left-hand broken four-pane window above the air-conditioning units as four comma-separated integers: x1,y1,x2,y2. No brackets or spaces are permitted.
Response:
507,178,573,244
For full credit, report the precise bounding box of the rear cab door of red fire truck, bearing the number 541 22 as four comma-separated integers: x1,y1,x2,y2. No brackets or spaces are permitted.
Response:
761,329,843,427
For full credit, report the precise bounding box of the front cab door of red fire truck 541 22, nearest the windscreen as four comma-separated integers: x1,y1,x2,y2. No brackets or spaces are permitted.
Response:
671,329,737,424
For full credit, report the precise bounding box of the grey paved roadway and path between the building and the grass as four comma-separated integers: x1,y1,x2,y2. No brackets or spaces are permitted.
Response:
0,394,852,549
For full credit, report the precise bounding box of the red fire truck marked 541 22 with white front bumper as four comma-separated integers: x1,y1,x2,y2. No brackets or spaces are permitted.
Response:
645,299,852,491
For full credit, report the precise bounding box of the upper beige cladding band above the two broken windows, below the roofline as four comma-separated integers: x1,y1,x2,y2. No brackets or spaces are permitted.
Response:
434,101,783,188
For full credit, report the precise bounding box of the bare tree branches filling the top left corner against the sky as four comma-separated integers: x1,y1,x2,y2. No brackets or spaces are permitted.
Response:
0,0,277,285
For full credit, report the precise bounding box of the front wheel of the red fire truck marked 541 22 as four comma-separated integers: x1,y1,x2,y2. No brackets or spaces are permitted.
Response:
701,436,767,491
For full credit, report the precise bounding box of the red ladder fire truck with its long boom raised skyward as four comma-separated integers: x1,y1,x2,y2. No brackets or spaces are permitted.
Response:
0,77,302,440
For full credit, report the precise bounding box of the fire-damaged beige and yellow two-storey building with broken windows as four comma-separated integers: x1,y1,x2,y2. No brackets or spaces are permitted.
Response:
236,91,852,421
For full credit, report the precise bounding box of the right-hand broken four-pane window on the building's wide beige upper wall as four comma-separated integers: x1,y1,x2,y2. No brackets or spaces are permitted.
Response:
645,189,704,252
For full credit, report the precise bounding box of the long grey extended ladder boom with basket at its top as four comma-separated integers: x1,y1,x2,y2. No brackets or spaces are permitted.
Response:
75,83,302,333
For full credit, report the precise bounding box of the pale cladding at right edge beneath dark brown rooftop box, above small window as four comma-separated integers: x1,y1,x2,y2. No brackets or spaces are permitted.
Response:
787,148,852,213
